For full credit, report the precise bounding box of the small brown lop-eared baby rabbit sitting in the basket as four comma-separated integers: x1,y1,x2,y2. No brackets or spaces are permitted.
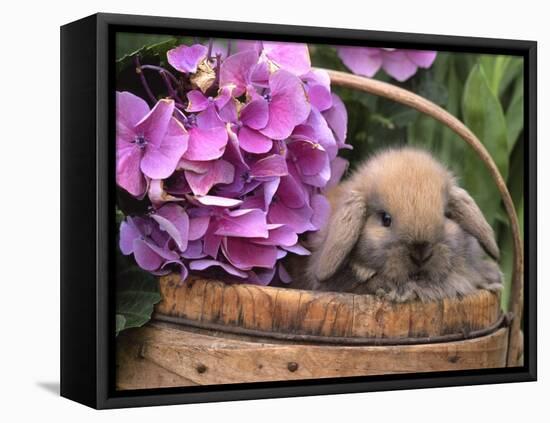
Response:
291,148,502,302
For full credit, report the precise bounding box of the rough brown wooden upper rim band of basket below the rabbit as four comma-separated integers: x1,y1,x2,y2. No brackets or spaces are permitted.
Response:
156,274,500,338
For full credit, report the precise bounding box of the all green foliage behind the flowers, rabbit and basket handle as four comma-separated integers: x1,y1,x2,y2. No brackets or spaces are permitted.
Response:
116,33,524,332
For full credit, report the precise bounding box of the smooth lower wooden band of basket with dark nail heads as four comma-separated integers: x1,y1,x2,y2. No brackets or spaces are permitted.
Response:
117,323,508,389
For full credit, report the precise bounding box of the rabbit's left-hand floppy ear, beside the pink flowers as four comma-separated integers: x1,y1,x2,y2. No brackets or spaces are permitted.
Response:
313,191,367,281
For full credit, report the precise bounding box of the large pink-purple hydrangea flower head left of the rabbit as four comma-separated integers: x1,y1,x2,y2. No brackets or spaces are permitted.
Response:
116,41,349,285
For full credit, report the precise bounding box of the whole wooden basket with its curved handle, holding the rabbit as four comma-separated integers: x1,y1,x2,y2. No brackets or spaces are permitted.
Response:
116,70,523,389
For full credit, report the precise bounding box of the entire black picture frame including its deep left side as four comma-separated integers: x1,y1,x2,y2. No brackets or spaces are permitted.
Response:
61,13,537,409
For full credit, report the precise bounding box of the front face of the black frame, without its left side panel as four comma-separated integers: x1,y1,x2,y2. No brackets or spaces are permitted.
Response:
62,13,537,408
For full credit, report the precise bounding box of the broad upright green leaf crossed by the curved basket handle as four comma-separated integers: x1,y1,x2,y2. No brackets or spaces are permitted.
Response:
462,64,508,226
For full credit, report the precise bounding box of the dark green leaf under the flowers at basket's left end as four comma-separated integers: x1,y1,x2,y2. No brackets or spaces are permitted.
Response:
116,265,160,334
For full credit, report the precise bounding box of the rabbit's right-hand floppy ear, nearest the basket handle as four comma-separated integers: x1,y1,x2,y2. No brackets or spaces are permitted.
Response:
448,185,500,260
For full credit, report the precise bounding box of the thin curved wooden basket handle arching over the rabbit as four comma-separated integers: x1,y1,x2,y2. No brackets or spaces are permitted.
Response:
323,69,523,366
